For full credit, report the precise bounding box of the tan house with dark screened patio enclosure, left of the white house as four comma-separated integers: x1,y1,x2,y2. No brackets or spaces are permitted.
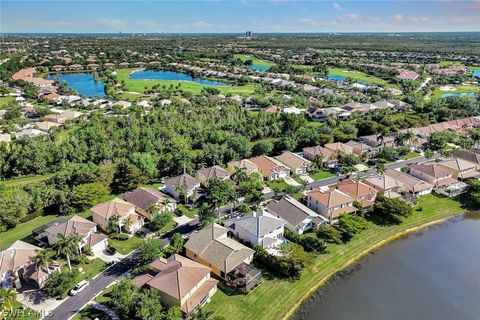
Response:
184,223,262,293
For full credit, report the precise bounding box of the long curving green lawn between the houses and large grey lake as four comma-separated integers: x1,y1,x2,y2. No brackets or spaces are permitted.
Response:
204,195,464,320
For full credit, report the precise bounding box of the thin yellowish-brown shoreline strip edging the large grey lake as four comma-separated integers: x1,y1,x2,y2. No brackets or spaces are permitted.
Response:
281,211,468,320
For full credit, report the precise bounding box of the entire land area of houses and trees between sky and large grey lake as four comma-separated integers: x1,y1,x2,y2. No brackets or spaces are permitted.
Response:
0,32,480,320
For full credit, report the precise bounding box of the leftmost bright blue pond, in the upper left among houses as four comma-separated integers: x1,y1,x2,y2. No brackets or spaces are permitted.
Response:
47,72,105,97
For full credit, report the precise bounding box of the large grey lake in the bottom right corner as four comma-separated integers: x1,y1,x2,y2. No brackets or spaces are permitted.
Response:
297,212,480,320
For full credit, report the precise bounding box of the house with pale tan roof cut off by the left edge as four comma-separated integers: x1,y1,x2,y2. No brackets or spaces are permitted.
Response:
0,240,60,289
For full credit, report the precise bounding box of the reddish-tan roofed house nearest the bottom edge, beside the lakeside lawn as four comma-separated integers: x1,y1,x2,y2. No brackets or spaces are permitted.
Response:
133,254,218,315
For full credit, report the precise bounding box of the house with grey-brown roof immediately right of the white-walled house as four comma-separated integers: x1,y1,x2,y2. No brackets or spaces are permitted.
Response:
265,196,327,234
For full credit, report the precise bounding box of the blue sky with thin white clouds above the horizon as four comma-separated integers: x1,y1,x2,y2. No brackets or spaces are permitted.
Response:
0,0,480,33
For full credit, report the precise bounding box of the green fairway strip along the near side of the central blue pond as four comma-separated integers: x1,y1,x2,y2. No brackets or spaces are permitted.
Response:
117,69,256,95
